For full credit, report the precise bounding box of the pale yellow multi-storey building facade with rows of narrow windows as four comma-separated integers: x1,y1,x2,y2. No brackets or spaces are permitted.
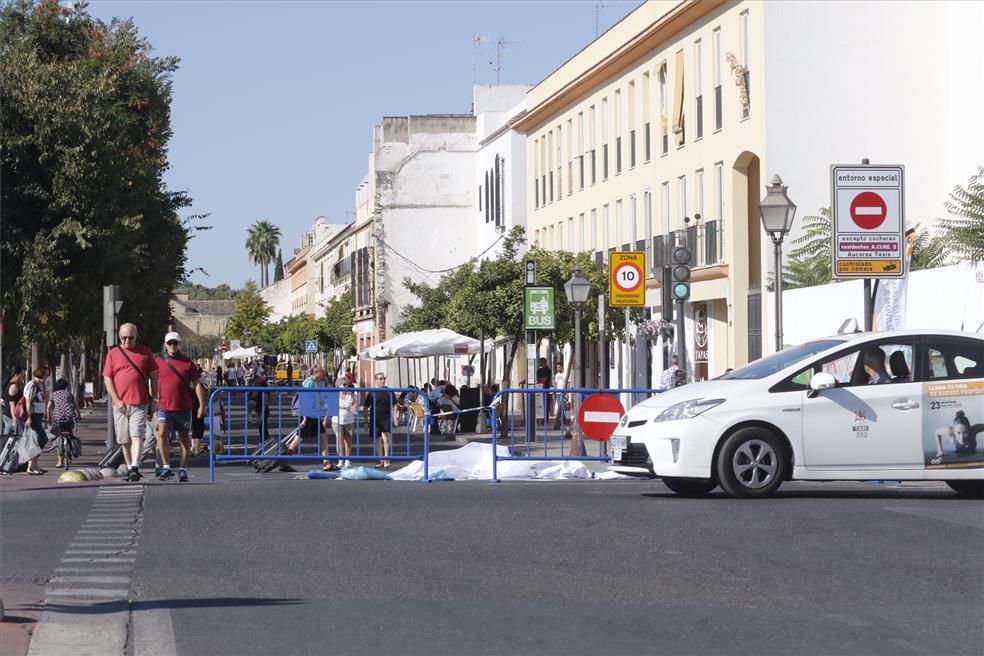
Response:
513,0,768,383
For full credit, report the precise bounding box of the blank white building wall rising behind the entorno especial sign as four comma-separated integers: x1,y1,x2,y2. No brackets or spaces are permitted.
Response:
752,1,984,236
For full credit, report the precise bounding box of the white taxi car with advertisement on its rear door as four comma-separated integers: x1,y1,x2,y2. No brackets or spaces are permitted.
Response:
609,331,984,497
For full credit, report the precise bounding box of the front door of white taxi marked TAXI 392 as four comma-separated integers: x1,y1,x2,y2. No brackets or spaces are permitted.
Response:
803,339,923,470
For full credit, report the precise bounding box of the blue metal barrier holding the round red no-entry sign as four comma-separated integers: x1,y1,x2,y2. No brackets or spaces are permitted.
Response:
486,387,665,483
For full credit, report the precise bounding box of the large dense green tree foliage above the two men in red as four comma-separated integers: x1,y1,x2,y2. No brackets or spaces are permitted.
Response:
0,0,194,358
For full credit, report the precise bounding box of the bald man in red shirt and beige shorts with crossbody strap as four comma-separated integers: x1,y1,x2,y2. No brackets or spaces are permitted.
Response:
103,323,157,483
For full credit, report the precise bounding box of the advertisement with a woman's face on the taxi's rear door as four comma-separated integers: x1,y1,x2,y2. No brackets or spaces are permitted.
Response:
923,380,984,469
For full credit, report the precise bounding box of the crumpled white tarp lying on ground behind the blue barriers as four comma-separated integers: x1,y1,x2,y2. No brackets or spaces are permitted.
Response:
390,442,591,481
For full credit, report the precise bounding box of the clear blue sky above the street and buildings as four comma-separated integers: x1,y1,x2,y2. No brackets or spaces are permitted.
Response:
82,0,638,287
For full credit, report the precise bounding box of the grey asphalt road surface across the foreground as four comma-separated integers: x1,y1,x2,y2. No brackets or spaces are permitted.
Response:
0,470,984,655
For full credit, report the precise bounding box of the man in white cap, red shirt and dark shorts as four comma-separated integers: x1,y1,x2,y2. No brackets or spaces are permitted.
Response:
157,332,206,483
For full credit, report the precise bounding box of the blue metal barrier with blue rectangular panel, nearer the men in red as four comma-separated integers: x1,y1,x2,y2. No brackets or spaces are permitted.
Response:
208,386,431,482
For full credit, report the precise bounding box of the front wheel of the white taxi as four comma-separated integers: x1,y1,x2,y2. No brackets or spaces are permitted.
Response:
717,427,787,498
